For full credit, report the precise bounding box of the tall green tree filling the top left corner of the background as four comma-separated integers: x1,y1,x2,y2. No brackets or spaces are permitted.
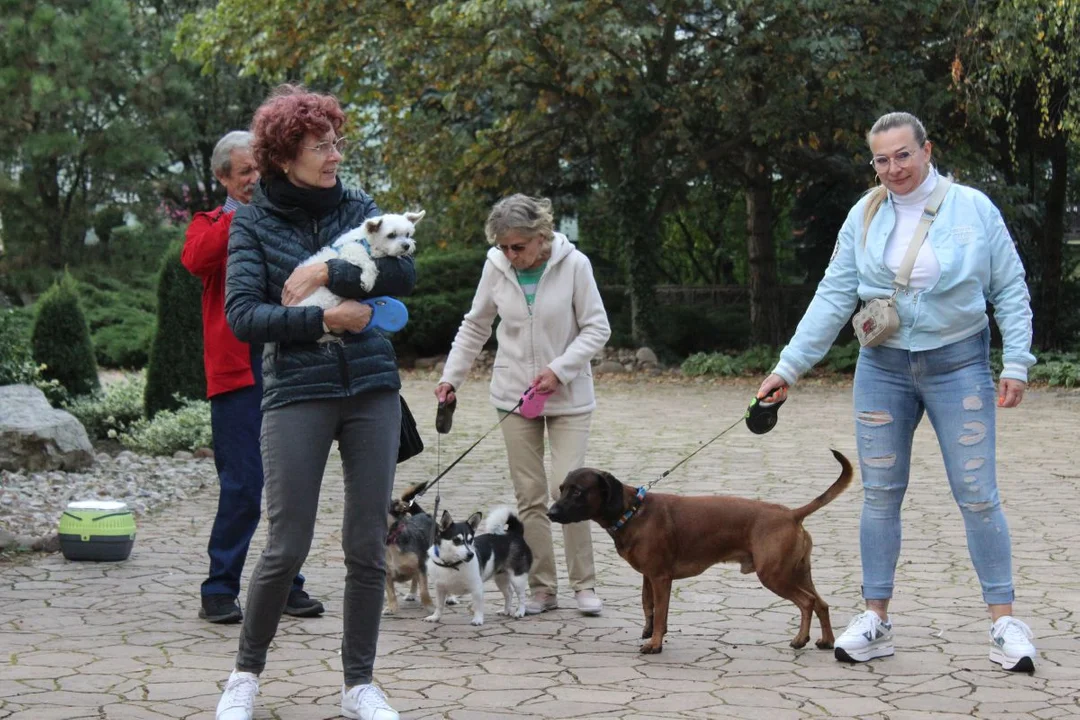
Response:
0,0,160,267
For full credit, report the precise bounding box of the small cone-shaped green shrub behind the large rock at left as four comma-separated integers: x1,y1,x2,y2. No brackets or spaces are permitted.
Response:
30,271,99,395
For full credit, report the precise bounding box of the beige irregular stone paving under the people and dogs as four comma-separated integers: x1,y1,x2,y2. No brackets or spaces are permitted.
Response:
0,378,1080,720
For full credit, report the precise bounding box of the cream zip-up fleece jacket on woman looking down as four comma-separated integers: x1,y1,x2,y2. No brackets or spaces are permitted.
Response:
440,232,611,416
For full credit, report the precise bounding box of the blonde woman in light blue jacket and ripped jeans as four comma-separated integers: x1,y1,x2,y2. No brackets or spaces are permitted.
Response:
757,112,1037,671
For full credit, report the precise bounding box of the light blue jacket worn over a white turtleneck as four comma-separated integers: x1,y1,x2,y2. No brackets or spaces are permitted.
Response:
773,178,1035,384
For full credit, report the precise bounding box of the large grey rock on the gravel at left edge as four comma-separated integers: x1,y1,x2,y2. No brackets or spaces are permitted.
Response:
0,385,94,472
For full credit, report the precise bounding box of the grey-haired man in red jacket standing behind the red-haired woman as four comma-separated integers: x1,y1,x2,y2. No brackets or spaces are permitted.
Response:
180,131,323,623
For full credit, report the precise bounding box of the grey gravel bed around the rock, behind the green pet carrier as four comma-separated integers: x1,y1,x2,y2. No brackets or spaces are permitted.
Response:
0,450,217,552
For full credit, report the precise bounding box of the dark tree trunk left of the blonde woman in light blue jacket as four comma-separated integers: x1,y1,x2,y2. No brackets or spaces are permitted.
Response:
745,151,784,347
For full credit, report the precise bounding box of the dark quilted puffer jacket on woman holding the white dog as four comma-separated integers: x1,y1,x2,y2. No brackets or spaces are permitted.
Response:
225,184,416,410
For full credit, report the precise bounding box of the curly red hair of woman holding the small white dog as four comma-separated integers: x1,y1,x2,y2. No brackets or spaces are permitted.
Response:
252,84,345,177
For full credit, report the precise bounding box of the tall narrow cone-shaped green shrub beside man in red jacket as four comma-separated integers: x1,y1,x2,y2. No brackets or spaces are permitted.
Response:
146,244,206,418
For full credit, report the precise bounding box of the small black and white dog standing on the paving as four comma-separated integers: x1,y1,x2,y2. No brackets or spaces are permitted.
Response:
424,507,532,625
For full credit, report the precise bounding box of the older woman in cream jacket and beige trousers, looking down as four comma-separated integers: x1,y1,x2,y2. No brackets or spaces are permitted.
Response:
435,194,611,614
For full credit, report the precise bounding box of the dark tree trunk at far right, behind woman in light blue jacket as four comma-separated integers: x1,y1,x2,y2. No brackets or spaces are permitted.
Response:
1035,131,1069,349
